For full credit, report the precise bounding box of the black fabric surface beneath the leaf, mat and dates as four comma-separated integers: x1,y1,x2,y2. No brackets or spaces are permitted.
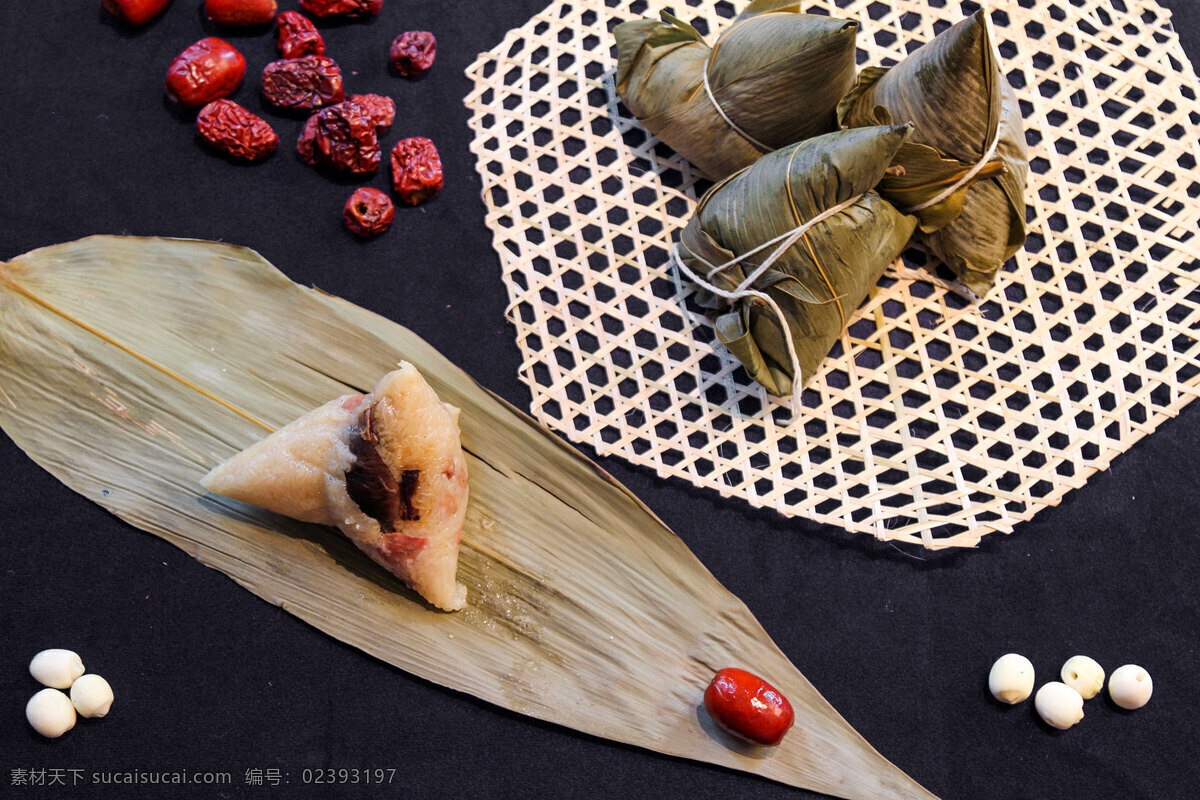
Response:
0,0,1200,800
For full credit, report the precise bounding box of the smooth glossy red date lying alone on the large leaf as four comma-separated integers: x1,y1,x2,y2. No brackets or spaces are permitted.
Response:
704,668,796,745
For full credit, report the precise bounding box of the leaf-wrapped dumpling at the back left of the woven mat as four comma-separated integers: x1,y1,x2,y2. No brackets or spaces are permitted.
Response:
614,0,858,180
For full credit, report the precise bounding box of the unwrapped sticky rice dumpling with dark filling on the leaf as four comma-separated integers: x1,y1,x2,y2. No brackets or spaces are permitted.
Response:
203,362,467,610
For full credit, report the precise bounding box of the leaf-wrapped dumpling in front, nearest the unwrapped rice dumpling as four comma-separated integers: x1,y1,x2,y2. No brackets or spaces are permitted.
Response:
677,125,917,396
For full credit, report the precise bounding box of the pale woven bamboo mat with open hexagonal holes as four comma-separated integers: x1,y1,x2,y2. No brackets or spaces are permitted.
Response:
466,0,1200,548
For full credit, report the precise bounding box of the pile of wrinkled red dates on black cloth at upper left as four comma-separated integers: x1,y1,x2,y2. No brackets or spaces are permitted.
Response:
102,0,444,237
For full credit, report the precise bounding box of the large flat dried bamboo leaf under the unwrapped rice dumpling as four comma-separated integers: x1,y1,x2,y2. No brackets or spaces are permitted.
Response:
0,236,932,800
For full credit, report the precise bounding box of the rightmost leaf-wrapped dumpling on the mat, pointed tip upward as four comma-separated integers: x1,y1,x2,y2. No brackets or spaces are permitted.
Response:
839,12,1028,296
